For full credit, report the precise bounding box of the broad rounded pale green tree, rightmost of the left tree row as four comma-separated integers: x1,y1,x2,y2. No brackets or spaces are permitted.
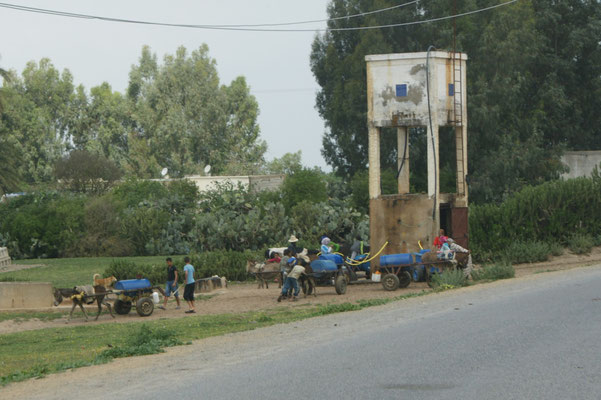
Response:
127,45,266,177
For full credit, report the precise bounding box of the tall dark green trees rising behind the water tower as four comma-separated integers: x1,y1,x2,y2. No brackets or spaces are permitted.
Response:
311,0,601,202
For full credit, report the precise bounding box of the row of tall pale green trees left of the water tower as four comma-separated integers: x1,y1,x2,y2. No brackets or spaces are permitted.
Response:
0,45,266,192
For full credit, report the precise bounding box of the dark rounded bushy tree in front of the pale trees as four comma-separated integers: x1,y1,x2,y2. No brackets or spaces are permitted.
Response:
56,150,122,193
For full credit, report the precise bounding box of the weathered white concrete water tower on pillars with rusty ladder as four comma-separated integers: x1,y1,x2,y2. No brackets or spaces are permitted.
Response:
365,51,468,260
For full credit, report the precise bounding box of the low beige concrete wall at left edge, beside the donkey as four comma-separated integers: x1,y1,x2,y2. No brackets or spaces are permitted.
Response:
0,282,54,310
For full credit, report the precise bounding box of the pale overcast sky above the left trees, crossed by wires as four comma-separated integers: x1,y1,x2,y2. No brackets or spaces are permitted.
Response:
0,0,330,170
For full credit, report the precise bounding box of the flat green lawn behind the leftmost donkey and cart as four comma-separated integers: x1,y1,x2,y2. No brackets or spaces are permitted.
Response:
0,256,165,287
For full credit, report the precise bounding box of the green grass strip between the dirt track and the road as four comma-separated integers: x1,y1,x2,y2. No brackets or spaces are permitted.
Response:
0,291,429,385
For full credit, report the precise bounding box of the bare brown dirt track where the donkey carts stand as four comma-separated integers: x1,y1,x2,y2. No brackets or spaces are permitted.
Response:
0,248,601,334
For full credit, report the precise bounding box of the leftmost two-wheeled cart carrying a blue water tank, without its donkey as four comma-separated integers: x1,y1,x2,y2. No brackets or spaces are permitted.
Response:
112,279,165,317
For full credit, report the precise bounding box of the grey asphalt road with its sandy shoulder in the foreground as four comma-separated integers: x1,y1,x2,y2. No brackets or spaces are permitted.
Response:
0,266,601,400
